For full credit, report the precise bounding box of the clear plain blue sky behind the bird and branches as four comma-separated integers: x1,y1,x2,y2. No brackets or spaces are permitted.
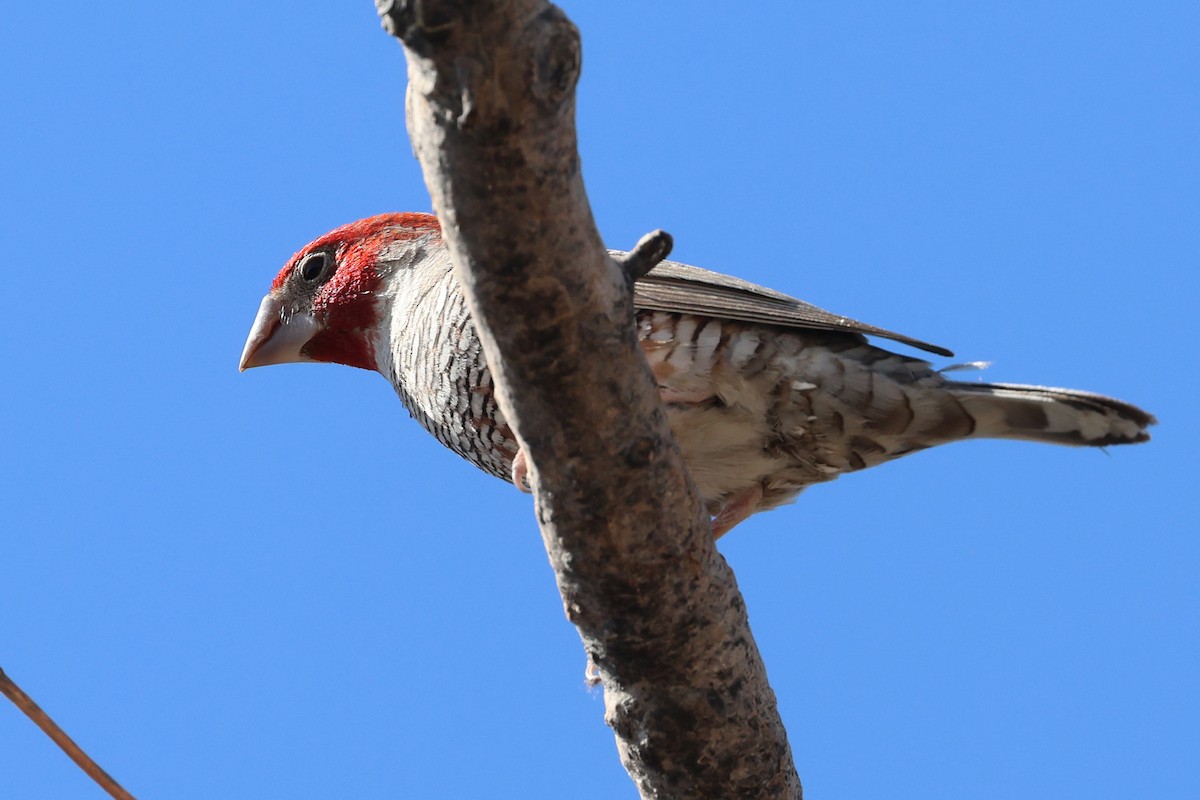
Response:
0,0,1200,800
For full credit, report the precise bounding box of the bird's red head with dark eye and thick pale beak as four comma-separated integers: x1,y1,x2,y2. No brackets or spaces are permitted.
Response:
241,213,440,369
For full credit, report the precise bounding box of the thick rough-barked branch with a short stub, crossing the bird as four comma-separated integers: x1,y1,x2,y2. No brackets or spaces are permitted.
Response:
377,0,800,800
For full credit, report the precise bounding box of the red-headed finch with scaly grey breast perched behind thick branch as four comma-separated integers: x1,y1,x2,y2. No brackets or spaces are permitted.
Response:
240,212,1156,537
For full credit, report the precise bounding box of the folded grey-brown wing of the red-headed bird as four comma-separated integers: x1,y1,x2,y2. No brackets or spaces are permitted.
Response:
634,261,954,356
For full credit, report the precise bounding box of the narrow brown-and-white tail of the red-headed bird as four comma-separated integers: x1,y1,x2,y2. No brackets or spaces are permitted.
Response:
950,383,1157,447
